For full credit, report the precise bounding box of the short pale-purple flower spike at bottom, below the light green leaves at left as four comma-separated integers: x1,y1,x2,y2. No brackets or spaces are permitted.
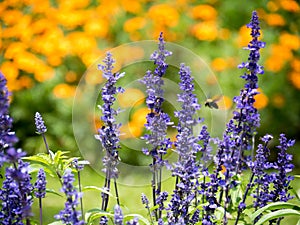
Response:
55,168,84,225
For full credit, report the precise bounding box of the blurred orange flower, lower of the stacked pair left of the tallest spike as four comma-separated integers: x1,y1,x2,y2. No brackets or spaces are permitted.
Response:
192,21,218,41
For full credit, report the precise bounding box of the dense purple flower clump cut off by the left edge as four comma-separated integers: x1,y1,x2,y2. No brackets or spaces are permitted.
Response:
0,72,33,224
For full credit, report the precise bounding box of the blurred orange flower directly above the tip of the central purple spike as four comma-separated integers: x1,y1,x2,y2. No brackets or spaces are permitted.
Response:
148,4,179,27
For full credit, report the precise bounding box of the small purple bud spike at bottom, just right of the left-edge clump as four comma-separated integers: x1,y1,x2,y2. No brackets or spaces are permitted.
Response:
34,169,47,225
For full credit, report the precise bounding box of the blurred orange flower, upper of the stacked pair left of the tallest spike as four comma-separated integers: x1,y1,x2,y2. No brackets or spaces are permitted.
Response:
191,4,218,20
